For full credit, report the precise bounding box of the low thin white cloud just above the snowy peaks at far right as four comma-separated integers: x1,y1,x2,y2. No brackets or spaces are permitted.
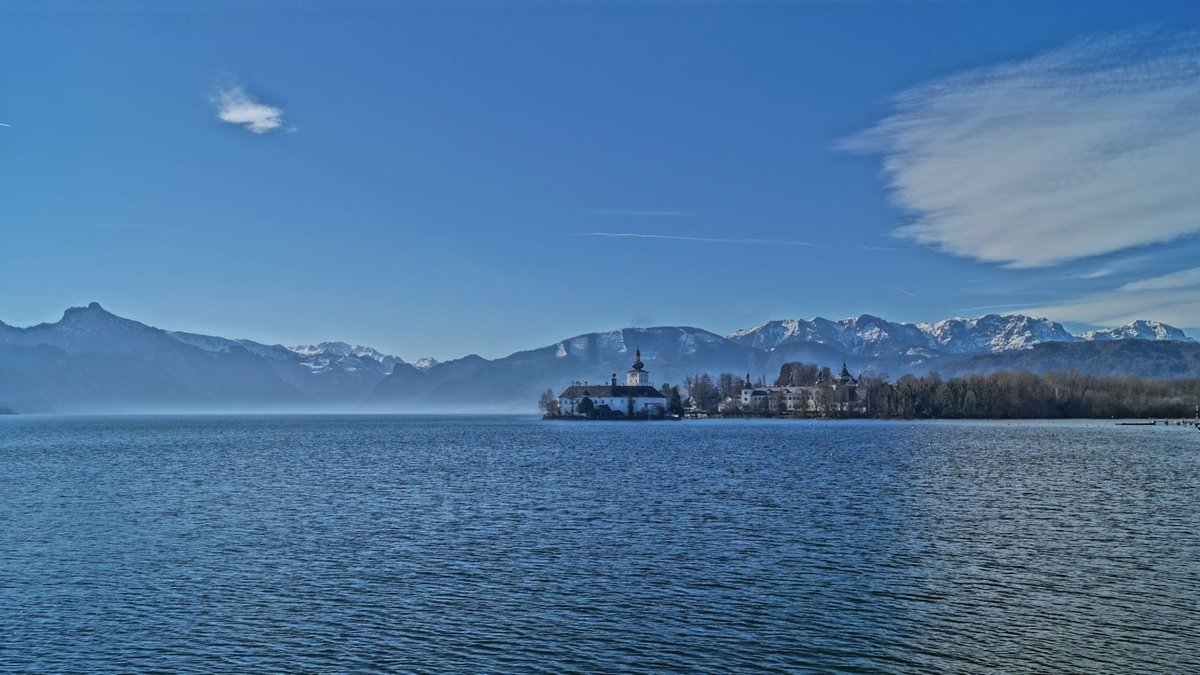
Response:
1019,268,1200,328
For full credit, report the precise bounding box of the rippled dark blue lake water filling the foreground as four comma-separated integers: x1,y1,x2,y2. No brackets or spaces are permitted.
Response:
0,417,1200,673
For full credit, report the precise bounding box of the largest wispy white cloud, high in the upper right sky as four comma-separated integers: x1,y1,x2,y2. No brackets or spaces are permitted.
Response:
842,31,1200,268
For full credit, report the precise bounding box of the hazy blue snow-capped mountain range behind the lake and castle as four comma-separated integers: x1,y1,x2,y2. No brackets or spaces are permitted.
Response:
0,303,1200,412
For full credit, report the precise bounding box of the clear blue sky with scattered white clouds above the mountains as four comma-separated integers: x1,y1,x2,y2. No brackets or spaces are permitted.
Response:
0,0,1200,360
